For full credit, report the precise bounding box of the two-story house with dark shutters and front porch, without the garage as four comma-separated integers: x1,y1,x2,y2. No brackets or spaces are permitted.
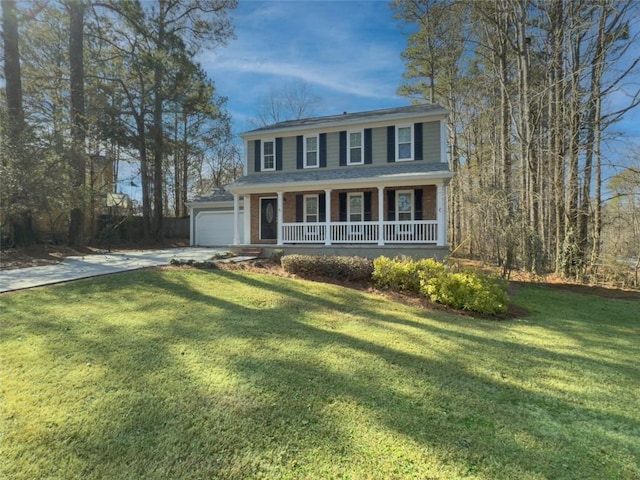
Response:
191,104,452,257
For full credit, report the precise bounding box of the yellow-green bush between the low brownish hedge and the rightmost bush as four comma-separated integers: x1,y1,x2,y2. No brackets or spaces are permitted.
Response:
371,256,447,293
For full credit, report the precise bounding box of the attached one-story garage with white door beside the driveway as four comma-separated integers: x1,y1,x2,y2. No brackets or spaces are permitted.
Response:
187,191,244,247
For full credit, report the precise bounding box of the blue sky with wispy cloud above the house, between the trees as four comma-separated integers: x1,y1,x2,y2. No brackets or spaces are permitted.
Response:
201,0,409,132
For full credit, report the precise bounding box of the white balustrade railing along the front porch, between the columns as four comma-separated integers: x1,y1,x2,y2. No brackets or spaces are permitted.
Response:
282,220,438,244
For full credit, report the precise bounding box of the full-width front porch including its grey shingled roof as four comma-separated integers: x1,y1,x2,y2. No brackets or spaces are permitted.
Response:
228,163,452,251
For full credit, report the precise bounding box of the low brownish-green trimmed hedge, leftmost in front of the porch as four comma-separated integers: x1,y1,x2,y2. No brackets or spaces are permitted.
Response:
281,255,373,281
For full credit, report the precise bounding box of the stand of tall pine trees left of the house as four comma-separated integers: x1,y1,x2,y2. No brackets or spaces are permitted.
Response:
0,0,242,245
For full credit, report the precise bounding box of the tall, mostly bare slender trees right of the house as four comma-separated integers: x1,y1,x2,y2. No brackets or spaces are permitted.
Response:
392,0,640,285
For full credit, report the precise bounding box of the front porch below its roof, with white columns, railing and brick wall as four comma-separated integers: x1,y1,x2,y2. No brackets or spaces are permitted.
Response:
233,182,447,247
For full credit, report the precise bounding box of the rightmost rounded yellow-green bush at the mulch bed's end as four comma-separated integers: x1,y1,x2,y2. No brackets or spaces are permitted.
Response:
420,271,509,315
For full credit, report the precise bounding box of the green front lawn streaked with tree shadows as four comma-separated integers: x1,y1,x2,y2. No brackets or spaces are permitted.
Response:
0,269,640,480
